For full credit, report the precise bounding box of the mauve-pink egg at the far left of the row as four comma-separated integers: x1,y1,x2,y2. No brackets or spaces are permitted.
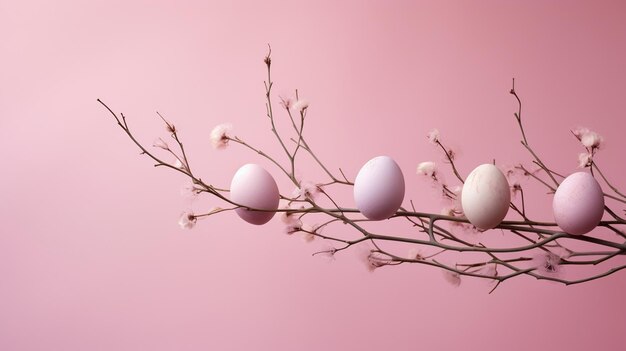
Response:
230,163,280,225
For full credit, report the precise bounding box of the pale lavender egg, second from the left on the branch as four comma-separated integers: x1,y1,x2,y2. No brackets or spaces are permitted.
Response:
354,156,404,221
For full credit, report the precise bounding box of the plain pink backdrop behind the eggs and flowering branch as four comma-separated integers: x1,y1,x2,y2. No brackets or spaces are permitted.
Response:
0,0,626,350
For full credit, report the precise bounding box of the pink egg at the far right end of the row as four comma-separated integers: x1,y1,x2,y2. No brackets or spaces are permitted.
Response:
552,172,604,235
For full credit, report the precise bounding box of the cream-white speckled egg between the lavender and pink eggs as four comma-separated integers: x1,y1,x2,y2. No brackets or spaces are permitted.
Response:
461,164,511,230
